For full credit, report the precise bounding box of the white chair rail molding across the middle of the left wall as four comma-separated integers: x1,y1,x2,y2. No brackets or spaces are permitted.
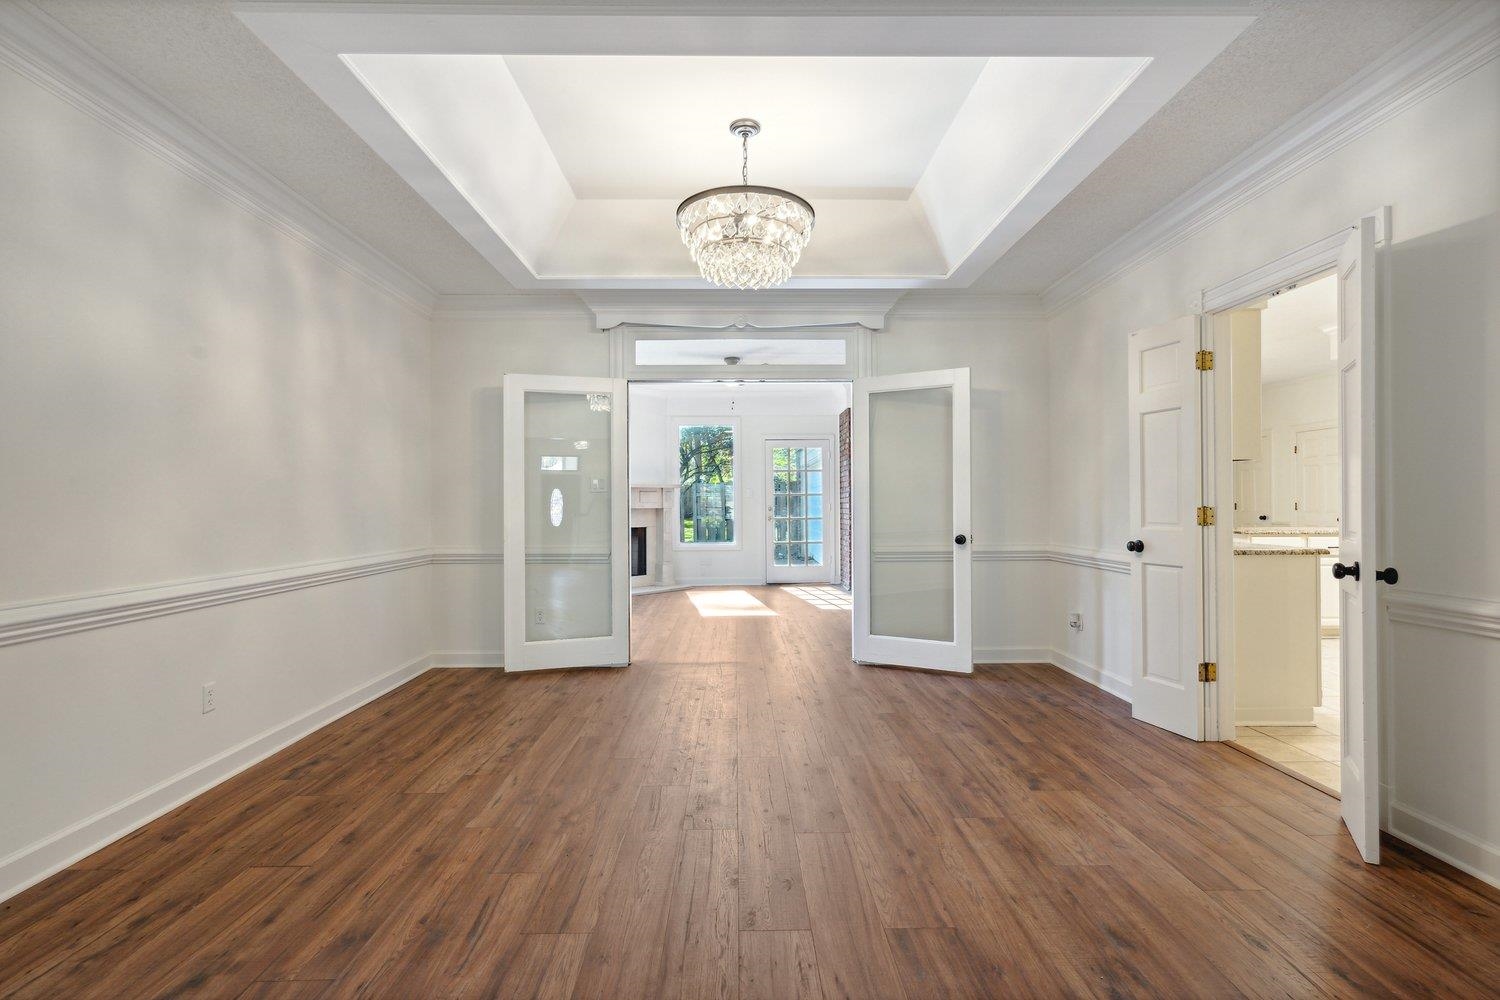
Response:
0,549,435,646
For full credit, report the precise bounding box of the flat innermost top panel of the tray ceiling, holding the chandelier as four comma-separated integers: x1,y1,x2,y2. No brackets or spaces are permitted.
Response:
504,55,986,205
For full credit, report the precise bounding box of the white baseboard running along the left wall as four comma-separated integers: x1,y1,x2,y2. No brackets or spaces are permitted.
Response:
0,654,431,900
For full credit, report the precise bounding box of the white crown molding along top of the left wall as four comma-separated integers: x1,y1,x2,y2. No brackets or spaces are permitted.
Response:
0,3,437,316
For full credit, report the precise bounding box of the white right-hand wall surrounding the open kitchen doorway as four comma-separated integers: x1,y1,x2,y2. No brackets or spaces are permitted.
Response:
1047,60,1500,879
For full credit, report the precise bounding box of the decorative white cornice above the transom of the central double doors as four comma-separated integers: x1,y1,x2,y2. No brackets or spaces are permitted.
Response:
578,288,906,330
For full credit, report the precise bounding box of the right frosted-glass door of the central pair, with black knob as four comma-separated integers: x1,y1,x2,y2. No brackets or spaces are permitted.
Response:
852,369,974,673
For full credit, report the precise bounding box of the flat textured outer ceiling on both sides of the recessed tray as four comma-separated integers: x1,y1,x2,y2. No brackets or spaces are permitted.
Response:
30,0,1455,294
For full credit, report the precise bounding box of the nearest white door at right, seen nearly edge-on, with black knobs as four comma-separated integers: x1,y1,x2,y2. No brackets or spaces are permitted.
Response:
1334,217,1382,864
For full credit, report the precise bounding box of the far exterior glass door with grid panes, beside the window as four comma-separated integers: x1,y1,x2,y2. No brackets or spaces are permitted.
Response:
765,438,839,583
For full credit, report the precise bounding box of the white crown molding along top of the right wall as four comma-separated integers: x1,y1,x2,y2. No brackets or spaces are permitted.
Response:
1043,0,1500,315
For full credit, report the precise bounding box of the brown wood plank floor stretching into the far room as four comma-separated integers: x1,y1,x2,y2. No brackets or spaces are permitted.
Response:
0,588,1500,1000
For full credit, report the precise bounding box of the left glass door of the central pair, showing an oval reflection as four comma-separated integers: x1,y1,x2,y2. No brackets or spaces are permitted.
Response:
503,375,630,670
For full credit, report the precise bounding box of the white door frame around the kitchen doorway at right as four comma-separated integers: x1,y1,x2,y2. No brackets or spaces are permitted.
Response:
1193,205,1391,779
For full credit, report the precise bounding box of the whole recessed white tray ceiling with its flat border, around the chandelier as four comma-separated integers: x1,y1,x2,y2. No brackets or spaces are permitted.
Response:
239,3,1251,288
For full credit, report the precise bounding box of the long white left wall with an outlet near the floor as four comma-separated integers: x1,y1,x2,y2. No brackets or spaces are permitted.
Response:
0,56,431,898
